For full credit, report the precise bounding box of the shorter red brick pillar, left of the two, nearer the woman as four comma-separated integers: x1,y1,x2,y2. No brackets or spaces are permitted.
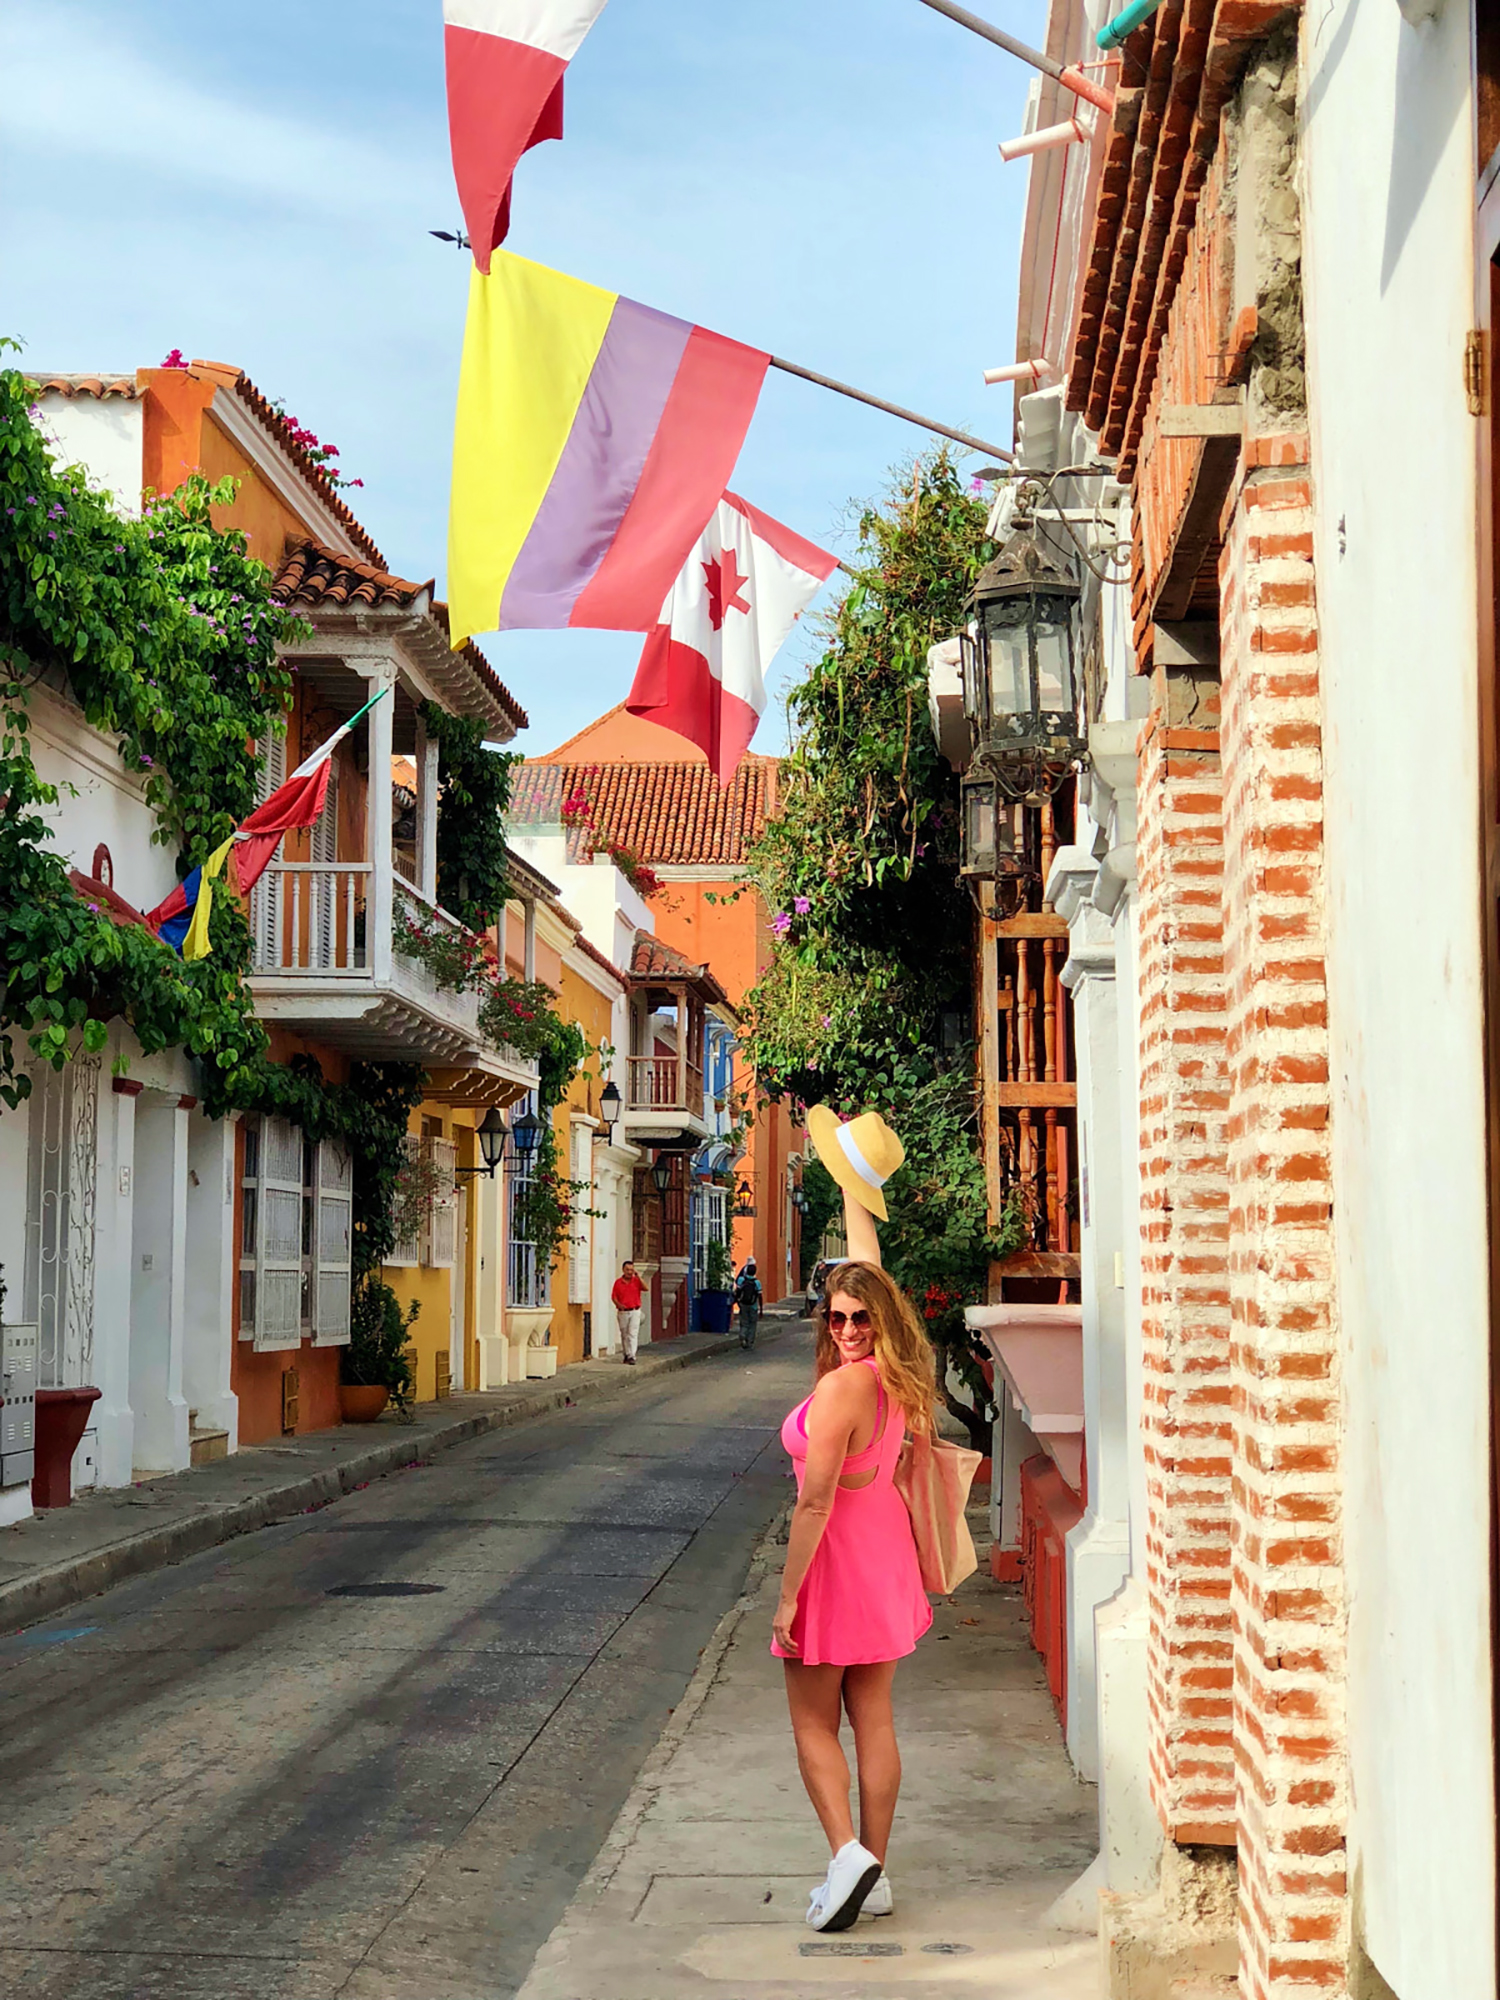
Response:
1136,710,1234,1842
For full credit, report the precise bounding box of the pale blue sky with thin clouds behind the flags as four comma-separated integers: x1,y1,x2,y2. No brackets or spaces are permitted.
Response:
0,0,1044,750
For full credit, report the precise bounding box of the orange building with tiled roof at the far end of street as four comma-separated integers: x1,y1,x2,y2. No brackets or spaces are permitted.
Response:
512,706,802,1300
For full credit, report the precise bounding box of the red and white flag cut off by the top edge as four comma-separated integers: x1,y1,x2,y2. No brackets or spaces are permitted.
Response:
442,0,604,272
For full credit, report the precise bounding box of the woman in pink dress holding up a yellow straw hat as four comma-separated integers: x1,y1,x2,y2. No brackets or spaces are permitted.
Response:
770,1104,936,1930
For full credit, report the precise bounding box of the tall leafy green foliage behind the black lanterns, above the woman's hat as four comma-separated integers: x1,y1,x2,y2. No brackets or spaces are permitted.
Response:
744,450,1020,1424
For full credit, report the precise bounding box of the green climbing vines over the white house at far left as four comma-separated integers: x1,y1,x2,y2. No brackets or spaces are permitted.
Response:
0,370,308,1106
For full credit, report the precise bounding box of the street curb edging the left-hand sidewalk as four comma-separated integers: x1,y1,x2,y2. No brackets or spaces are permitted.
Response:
0,1340,804,1632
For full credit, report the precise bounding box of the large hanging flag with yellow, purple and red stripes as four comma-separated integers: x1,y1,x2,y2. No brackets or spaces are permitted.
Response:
448,250,770,646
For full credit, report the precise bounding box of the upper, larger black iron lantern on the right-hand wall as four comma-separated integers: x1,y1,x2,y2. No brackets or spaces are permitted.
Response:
964,514,1084,800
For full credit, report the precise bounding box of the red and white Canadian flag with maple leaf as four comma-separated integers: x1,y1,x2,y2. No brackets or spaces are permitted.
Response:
626,494,838,784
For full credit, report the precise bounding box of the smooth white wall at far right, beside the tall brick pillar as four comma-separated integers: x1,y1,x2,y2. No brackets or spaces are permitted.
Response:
1304,0,1494,2000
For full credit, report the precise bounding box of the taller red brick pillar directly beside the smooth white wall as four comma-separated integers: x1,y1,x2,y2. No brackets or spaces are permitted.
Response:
1220,436,1348,2000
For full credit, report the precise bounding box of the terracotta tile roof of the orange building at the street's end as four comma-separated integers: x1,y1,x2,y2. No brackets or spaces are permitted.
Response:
510,756,776,868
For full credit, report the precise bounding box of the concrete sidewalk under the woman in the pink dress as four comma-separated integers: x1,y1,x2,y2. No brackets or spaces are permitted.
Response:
520,1504,1100,2000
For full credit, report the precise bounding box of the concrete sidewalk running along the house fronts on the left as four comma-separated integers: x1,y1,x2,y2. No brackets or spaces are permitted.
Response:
0,1310,788,1632
